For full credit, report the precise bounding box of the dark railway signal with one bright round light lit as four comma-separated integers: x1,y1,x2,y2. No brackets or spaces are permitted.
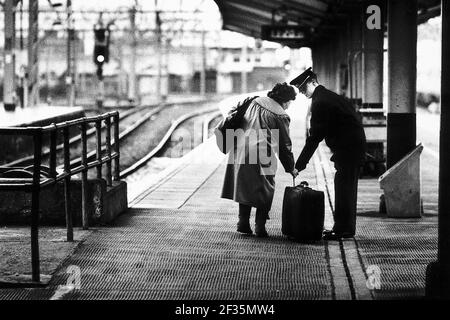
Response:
93,21,110,108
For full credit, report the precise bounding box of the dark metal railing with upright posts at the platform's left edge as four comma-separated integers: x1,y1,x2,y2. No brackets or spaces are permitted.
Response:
0,111,120,282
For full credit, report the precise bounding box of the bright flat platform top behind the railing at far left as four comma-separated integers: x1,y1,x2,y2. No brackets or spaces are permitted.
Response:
0,106,84,127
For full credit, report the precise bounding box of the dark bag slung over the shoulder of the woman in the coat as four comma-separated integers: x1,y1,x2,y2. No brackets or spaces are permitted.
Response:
214,96,258,154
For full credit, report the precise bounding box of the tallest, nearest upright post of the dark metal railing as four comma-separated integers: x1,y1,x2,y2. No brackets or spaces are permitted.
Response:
31,130,42,282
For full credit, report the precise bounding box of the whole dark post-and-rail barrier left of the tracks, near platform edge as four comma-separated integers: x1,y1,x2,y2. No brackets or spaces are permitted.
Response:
2,112,125,283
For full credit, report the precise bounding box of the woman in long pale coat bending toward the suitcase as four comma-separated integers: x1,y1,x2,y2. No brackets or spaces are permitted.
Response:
222,83,298,237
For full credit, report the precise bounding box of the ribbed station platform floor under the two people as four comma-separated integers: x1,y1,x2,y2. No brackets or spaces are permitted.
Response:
0,98,437,300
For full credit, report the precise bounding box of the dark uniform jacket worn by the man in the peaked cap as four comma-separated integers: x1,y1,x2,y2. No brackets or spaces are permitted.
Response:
295,86,366,170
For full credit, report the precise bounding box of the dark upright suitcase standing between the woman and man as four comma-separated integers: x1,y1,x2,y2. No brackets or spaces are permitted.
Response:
281,180,325,241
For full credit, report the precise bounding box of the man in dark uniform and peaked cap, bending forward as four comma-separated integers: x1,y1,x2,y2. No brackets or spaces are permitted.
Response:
290,68,366,240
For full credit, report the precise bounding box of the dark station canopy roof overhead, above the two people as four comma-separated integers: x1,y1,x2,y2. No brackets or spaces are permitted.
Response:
214,0,441,47
